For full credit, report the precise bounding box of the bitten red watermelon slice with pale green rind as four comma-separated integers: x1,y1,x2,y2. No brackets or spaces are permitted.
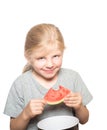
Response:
44,86,70,105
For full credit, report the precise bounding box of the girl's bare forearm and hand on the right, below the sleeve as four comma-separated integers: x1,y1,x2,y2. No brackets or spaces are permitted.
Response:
64,92,89,124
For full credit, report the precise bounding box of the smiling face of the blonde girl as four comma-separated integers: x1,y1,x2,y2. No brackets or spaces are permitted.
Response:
29,48,63,79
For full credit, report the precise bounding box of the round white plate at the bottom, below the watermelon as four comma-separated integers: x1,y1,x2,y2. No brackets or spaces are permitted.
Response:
37,116,79,130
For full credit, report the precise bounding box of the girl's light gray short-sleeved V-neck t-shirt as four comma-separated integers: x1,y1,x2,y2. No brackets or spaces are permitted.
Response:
4,68,92,130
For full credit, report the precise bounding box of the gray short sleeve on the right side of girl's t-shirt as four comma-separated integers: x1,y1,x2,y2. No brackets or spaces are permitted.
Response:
75,73,93,105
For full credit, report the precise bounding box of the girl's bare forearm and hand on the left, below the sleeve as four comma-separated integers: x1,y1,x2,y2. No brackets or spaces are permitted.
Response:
10,99,45,130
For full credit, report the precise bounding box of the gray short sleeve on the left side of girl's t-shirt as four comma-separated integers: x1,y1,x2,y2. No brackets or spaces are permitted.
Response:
4,82,24,117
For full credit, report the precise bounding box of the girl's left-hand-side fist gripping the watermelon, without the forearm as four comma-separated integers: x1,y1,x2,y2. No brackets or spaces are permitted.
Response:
24,99,46,119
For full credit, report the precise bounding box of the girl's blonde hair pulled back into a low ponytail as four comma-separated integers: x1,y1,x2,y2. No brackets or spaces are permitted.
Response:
23,23,65,73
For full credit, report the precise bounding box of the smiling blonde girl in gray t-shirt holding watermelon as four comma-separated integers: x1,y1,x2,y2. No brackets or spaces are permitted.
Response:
4,24,92,130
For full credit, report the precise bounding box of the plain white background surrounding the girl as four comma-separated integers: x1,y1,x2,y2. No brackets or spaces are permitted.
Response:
0,0,107,130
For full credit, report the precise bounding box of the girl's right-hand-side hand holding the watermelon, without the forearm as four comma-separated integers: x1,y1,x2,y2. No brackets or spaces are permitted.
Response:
64,92,82,110
